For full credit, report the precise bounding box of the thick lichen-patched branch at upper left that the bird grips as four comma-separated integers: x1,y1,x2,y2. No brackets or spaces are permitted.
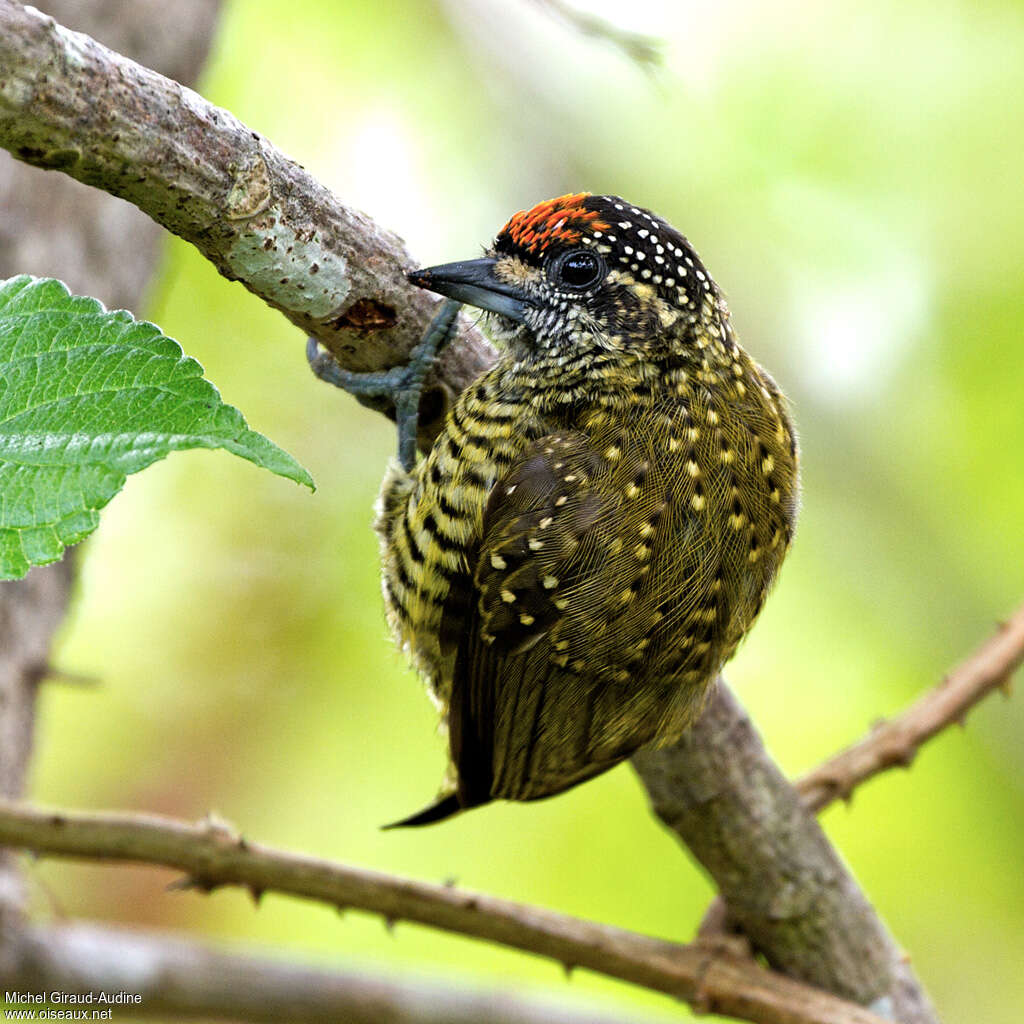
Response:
0,0,493,442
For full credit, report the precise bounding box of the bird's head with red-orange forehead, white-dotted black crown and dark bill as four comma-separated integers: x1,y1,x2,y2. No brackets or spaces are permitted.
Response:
409,193,727,359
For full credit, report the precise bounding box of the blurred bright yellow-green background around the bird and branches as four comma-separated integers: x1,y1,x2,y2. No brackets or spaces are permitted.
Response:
24,0,1024,1024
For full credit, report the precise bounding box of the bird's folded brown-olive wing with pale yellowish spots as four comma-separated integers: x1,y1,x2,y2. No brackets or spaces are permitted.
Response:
441,431,678,807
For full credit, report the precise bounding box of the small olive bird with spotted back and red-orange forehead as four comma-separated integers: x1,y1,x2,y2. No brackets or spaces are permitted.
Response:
311,193,799,826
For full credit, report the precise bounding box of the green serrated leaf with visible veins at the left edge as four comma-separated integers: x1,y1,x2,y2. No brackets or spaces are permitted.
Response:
0,275,313,580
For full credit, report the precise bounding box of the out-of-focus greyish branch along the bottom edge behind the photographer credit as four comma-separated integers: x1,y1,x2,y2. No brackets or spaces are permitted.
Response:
0,922,671,1024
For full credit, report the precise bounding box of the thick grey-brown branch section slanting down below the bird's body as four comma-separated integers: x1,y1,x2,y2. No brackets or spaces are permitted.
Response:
633,685,937,1024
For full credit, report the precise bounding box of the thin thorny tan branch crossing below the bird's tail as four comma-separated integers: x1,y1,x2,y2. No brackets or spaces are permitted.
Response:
0,804,882,1024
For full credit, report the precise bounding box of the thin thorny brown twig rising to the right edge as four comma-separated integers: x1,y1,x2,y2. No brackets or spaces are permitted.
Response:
796,605,1024,811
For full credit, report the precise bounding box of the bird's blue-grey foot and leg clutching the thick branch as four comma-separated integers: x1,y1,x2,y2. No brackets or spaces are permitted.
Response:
306,299,462,471
